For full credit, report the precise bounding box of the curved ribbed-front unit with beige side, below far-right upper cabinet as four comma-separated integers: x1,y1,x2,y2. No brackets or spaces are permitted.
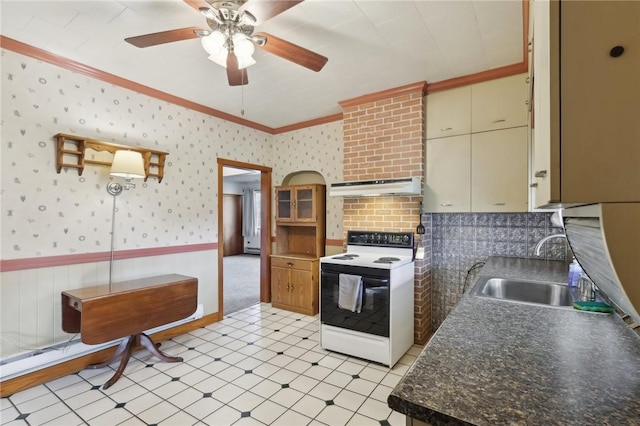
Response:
561,203,640,324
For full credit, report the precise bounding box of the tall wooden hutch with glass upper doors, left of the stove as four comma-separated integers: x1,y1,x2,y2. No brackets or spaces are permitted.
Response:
271,184,326,315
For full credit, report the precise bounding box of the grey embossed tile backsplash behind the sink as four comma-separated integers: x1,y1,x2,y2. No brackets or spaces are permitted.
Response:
429,213,571,330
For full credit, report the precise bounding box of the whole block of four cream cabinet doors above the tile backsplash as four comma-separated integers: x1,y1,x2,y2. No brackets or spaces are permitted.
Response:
424,74,529,213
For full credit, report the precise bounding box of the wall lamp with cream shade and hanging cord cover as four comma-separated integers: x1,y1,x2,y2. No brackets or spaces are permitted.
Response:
107,150,146,286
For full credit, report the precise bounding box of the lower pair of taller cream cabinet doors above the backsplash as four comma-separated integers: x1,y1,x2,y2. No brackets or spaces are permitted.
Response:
425,127,528,213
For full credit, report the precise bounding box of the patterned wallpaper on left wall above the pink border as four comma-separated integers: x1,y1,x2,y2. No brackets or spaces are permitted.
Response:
0,50,276,260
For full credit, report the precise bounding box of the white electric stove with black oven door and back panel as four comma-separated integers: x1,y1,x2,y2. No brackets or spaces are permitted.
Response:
320,231,414,367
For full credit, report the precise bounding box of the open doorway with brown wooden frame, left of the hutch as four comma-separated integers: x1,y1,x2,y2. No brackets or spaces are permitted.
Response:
218,158,271,316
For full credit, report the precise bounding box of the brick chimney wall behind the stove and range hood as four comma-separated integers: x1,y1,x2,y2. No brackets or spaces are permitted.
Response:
341,85,431,344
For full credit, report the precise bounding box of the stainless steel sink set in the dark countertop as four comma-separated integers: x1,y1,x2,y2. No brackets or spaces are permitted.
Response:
471,277,576,307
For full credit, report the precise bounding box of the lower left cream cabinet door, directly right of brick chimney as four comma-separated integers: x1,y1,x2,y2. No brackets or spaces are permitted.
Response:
424,135,471,213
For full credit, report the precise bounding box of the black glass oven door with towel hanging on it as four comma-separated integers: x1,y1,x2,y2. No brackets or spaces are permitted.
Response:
320,263,390,337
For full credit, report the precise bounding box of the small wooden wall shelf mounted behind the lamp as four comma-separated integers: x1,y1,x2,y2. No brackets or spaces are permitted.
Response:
55,133,169,182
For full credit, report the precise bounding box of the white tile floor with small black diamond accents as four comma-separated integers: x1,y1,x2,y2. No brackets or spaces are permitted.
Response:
0,303,422,426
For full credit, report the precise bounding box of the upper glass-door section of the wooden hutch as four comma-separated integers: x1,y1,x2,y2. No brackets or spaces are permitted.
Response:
276,185,324,222
